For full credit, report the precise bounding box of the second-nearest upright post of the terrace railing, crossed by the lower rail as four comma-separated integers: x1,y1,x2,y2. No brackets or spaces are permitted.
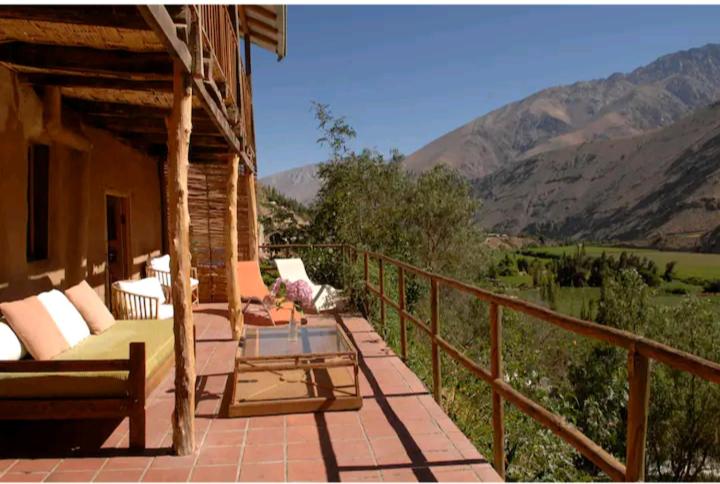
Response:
490,303,505,479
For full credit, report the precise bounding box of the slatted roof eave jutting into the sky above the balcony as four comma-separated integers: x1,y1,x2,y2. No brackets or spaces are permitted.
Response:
239,5,287,60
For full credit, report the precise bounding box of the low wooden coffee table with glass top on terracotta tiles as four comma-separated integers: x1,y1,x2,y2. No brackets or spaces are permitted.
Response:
228,323,362,417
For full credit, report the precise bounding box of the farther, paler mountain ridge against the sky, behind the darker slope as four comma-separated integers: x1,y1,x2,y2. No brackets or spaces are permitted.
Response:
405,44,720,179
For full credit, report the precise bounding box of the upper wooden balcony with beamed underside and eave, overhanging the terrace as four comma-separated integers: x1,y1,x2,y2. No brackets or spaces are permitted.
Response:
0,5,285,171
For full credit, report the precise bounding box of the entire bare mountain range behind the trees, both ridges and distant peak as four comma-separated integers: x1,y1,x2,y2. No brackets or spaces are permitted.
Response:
261,44,720,248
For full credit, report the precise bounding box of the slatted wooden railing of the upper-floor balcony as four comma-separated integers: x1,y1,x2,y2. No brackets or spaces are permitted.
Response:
196,5,241,105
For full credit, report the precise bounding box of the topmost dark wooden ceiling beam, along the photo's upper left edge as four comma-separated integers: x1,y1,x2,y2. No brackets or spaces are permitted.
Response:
0,5,150,30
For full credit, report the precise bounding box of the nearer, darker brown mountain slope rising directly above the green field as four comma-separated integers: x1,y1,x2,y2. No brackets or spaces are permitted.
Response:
476,103,720,247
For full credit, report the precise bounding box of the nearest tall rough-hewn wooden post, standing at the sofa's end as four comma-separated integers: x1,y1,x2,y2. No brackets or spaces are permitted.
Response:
167,61,195,455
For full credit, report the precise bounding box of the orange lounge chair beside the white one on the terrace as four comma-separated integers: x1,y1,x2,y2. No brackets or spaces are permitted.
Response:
235,260,302,326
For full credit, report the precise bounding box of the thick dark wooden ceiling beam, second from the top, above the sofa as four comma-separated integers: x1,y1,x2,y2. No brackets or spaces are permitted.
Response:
0,41,172,80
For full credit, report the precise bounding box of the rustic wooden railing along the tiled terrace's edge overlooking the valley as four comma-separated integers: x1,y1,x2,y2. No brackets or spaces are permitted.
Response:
263,244,720,481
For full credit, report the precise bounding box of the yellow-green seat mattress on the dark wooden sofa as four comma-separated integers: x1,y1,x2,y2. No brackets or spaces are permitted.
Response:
0,319,174,399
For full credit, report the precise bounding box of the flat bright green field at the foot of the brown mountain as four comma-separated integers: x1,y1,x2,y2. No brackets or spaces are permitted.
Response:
527,245,720,281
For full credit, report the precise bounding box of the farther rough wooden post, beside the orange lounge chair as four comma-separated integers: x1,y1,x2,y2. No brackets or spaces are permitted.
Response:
225,153,243,341
